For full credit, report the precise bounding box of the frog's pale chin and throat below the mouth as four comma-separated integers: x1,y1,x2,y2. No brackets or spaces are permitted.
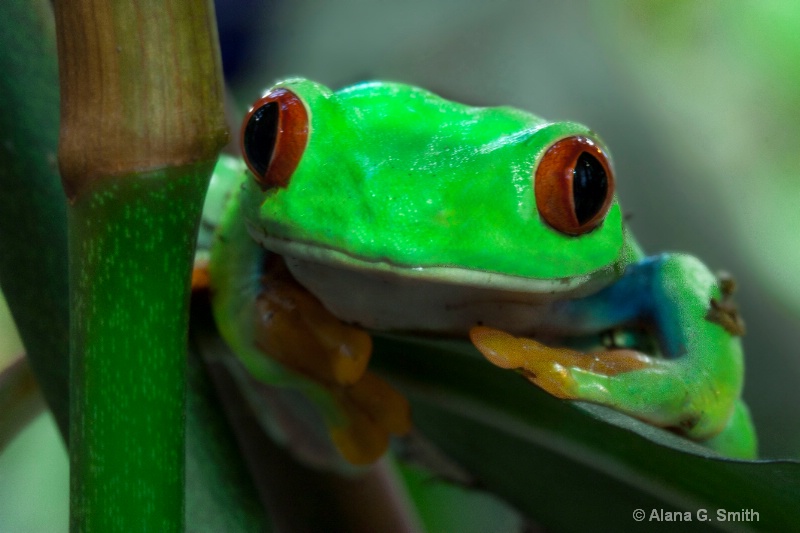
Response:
258,235,619,335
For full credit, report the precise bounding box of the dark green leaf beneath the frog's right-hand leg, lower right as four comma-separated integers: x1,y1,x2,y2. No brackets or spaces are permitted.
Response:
376,338,800,531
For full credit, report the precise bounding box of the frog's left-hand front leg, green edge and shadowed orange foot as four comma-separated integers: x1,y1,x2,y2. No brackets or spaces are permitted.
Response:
208,185,410,464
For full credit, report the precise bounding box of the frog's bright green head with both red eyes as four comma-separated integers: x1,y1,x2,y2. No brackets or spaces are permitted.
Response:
242,79,626,330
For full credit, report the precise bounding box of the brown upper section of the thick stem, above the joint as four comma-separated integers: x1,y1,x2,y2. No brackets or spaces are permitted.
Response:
55,0,228,198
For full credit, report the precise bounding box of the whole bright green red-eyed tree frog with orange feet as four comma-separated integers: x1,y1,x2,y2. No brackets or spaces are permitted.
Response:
201,79,756,463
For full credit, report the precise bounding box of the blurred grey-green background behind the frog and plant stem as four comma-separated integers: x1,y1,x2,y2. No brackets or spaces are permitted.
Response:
0,0,800,531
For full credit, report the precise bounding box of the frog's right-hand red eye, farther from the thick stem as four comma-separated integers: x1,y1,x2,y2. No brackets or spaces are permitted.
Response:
534,135,614,235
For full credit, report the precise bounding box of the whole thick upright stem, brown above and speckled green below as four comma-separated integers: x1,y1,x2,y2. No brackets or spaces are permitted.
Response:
55,0,227,532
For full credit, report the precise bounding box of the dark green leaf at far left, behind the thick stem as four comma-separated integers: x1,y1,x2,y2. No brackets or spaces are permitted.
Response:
0,0,69,438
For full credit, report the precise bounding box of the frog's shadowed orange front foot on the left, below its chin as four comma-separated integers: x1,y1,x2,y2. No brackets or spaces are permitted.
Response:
254,255,411,464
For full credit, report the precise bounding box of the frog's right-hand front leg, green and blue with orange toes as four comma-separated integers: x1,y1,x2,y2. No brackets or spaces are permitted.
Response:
470,255,756,458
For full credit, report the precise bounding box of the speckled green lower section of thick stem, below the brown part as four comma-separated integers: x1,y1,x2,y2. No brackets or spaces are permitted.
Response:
69,163,211,531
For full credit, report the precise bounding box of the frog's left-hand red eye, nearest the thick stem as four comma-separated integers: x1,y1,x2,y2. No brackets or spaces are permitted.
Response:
241,88,308,190
